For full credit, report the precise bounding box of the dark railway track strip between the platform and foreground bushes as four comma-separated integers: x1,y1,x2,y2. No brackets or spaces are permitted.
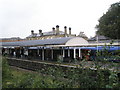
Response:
7,58,120,73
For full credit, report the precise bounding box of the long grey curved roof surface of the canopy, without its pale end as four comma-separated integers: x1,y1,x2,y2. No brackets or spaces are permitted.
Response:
1,37,73,46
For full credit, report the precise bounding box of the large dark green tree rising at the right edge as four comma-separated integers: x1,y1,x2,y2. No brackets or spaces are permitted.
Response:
96,2,120,39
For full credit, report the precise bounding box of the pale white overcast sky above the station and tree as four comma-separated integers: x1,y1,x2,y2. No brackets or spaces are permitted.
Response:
0,0,119,38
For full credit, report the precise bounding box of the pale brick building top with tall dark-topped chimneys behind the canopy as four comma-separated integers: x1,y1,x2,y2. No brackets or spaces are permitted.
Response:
26,25,76,40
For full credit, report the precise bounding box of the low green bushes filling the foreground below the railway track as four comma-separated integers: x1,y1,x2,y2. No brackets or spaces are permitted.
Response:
3,58,119,88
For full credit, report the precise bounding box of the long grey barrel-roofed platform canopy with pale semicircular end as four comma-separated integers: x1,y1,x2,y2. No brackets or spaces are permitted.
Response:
1,37,89,47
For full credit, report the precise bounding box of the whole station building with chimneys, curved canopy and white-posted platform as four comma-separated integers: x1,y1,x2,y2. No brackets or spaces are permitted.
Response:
0,25,120,61
